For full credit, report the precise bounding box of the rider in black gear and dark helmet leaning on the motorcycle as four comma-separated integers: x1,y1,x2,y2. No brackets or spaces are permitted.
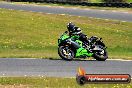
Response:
67,22,89,44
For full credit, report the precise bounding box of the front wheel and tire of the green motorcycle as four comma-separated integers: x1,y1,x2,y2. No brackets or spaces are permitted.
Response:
58,46,75,61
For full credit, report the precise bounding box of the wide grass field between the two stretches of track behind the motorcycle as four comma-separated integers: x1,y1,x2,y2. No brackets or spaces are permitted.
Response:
0,9,132,59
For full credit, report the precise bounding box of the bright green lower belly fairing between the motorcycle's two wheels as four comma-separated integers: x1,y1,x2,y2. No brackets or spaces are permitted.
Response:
76,48,93,57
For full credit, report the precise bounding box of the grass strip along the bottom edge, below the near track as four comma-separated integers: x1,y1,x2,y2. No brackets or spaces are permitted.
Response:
0,77,132,88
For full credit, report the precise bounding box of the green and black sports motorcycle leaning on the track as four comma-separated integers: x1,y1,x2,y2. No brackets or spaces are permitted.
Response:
58,31,108,61
